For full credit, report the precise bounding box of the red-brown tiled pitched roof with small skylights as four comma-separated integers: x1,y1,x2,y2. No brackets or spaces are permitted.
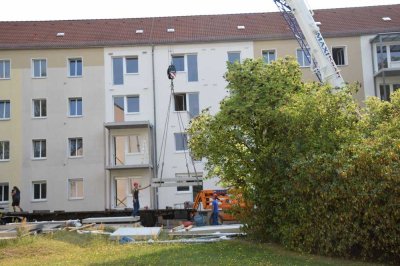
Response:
0,4,400,49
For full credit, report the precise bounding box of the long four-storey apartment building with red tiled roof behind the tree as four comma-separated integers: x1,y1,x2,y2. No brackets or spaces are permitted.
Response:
0,5,400,211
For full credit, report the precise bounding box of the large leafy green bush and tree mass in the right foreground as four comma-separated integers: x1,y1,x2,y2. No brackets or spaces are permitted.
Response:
188,58,400,261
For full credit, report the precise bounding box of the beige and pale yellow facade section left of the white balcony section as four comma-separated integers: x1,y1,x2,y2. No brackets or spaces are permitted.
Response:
0,48,105,211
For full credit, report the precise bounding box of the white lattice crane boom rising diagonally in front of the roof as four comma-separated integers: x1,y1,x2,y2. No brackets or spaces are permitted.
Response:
274,0,345,88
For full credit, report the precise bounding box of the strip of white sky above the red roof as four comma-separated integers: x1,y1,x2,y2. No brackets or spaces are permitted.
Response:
0,0,400,21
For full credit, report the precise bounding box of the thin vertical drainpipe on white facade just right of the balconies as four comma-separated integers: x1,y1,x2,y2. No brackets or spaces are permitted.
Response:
151,44,158,209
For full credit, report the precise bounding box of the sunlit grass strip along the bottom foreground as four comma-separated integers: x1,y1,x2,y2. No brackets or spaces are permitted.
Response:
0,231,384,266
